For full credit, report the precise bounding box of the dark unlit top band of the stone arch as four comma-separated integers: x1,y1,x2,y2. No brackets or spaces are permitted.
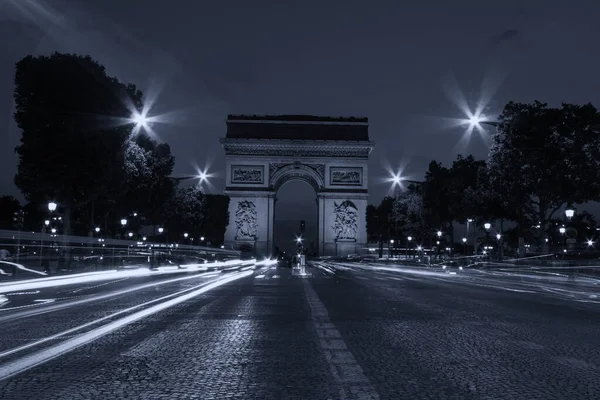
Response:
225,115,369,142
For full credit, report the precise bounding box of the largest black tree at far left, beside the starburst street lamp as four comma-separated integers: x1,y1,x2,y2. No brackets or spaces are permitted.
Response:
14,53,142,233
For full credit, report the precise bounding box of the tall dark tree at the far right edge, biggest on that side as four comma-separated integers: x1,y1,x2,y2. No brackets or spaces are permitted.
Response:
488,101,600,246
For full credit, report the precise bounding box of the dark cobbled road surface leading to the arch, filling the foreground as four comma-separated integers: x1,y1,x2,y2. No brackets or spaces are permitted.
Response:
0,264,600,400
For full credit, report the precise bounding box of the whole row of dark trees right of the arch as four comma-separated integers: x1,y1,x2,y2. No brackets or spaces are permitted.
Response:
367,102,600,248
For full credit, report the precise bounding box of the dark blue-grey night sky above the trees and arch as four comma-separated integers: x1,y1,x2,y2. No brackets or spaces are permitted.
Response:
0,0,600,250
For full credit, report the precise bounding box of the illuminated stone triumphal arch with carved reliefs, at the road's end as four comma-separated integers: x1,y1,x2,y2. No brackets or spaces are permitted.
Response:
220,115,374,256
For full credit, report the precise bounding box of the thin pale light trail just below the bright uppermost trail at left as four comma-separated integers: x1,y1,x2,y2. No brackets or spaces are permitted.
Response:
0,272,220,322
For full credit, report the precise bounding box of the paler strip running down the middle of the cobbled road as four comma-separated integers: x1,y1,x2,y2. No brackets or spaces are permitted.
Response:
303,280,379,400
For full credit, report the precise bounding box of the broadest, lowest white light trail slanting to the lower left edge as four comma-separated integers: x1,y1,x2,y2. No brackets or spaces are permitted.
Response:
0,271,252,381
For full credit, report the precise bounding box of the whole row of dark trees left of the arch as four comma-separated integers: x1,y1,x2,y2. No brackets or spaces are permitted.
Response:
0,53,229,243
